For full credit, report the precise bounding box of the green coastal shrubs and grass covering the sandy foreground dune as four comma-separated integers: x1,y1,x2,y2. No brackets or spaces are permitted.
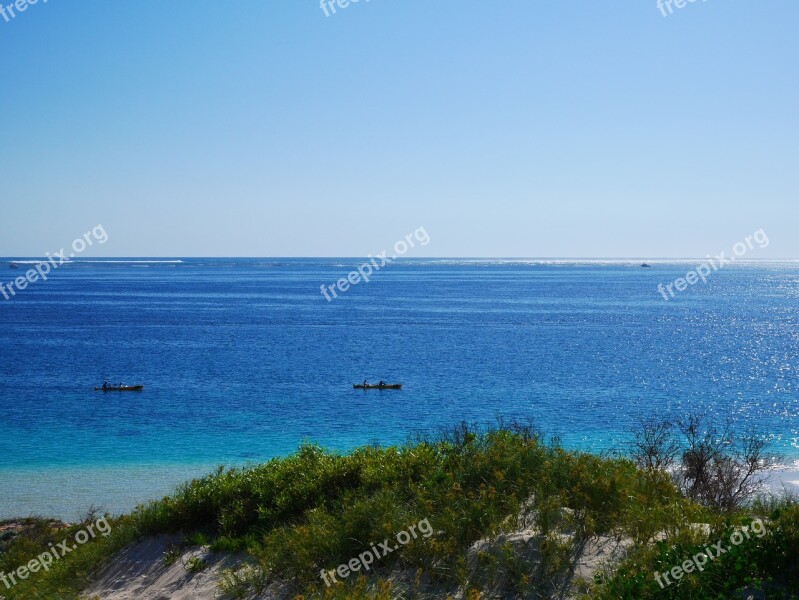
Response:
0,418,799,600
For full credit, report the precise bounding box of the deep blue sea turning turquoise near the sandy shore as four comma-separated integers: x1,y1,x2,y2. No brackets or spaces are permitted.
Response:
0,259,799,518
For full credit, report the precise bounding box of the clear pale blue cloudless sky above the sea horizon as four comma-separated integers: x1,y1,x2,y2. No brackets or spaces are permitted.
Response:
0,0,799,258
